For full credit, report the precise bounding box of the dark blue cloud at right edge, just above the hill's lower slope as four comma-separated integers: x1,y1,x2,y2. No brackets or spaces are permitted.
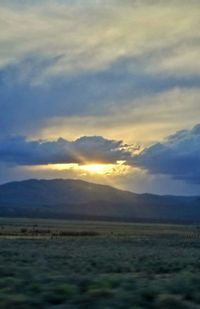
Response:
132,125,200,184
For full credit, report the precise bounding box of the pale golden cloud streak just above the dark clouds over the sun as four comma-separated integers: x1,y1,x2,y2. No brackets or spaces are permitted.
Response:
38,87,200,146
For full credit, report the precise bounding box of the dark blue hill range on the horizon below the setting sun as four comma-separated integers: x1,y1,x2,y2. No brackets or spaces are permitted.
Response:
0,179,200,222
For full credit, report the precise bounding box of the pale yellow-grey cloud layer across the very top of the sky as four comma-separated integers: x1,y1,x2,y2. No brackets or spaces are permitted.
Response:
0,0,200,85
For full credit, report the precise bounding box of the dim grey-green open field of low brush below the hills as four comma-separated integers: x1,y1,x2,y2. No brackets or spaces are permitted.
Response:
0,218,200,309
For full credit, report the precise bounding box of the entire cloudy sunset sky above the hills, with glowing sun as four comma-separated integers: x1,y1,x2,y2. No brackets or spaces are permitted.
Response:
0,0,200,195
